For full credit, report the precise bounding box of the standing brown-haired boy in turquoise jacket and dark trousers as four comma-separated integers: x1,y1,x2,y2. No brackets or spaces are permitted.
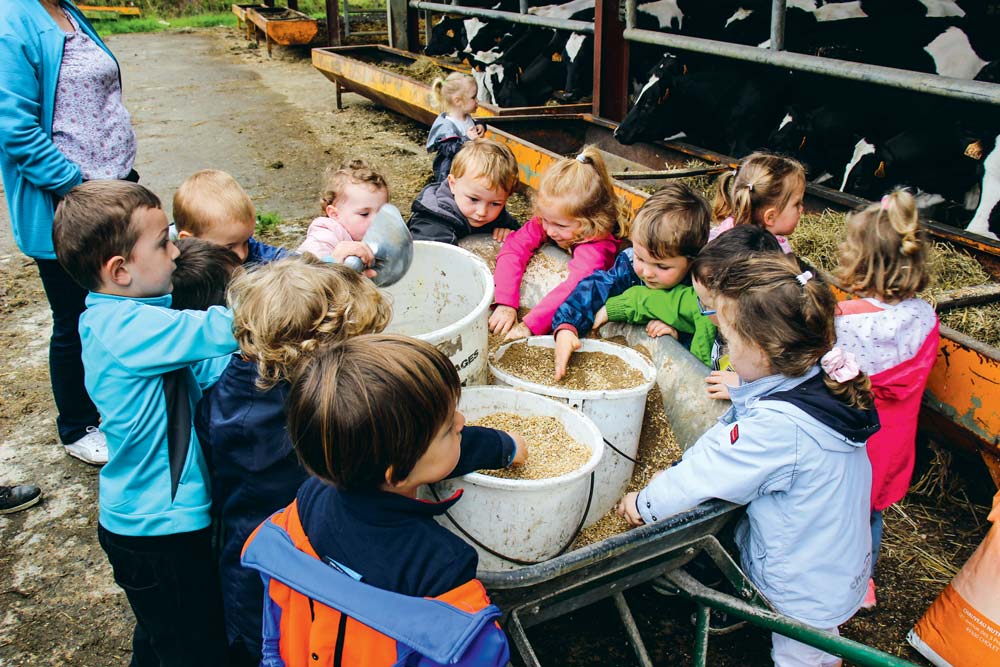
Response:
53,181,236,665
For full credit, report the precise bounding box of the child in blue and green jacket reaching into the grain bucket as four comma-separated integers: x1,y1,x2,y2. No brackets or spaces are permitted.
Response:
552,183,715,380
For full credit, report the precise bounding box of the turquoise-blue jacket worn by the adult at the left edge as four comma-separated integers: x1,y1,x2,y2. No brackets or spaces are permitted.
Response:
0,0,120,259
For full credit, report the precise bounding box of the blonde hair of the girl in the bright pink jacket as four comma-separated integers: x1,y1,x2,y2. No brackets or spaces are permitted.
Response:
532,146,630,242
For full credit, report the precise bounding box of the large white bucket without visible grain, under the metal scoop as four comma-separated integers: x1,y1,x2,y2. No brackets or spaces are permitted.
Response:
382,241,493,385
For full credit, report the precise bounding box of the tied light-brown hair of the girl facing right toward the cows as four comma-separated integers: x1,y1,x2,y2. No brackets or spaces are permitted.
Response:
712,153,806,227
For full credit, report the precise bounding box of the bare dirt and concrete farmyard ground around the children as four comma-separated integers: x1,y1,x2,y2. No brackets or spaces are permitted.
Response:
0,29,986,667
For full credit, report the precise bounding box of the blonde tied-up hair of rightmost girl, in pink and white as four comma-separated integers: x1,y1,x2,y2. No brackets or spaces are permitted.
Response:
837,190,930,302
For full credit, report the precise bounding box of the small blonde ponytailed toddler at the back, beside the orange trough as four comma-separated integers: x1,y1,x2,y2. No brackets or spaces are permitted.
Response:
427,72,486,183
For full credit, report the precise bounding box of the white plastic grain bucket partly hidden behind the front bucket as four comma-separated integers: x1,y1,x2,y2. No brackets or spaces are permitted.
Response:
490,336,656,526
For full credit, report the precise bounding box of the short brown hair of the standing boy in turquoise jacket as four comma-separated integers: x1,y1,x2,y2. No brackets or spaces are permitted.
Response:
52,181,160,290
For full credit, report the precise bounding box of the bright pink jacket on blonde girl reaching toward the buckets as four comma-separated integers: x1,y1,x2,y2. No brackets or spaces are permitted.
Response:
493,218,618,336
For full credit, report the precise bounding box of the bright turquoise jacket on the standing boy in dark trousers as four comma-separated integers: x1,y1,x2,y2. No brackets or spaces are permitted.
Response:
80,292,236,536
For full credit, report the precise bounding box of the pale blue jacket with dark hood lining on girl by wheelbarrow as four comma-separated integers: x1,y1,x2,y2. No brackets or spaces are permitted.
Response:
636,366,879,628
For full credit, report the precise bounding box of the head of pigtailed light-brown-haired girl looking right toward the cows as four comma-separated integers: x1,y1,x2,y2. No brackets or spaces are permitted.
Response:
708,153,806,253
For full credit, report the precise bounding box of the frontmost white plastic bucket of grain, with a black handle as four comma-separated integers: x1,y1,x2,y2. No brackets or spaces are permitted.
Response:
433,387,604,571
